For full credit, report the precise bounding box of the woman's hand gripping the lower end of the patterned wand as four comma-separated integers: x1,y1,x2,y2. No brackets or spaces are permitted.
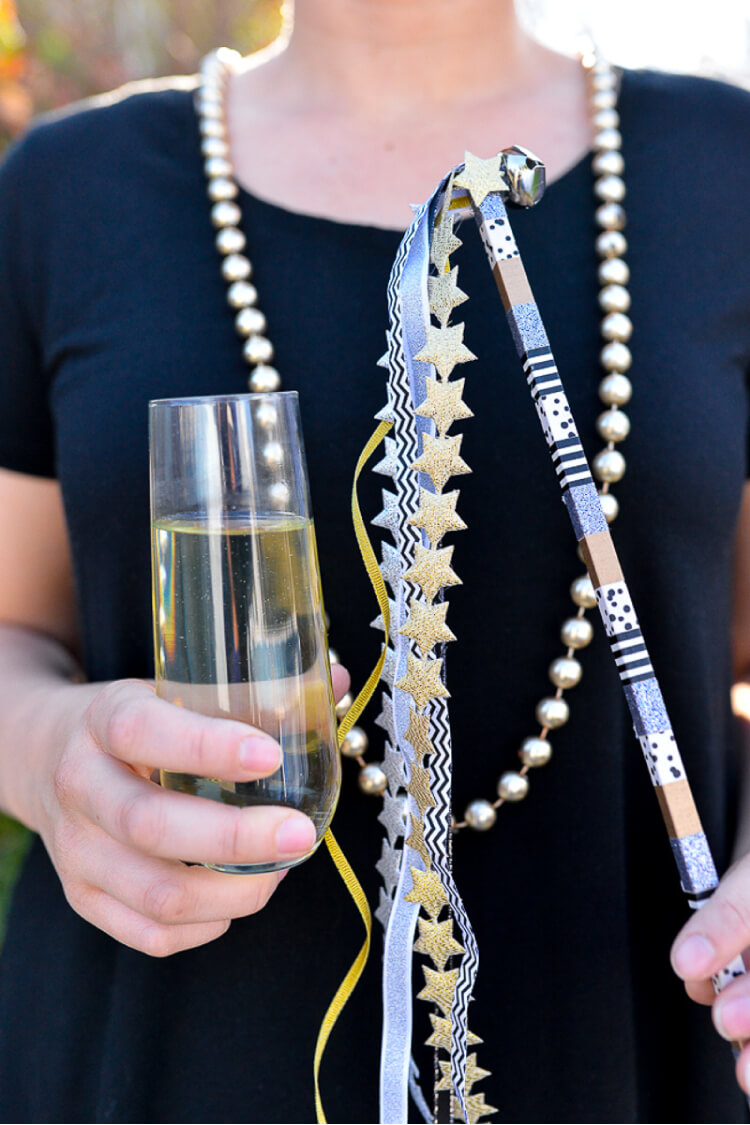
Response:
671,855,750,1094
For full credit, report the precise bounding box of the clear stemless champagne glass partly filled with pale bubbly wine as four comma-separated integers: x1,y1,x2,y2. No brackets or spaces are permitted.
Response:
150,392,341,874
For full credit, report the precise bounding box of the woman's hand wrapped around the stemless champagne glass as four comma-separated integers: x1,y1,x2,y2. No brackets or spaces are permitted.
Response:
34,666,349,956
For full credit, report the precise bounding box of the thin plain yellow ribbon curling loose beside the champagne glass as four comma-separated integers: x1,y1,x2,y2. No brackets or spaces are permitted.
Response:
313,422,392,1125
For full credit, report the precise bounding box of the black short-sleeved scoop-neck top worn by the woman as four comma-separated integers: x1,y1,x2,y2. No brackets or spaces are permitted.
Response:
0,72,750,1123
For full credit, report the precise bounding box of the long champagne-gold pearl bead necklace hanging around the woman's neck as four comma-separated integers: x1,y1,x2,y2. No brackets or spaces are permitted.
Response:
196,47,633,831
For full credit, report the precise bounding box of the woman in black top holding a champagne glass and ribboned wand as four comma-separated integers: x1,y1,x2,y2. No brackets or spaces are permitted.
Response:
0,0,750,1122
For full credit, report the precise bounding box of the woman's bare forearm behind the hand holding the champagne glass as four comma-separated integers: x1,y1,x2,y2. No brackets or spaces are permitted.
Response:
0,624,96,830
